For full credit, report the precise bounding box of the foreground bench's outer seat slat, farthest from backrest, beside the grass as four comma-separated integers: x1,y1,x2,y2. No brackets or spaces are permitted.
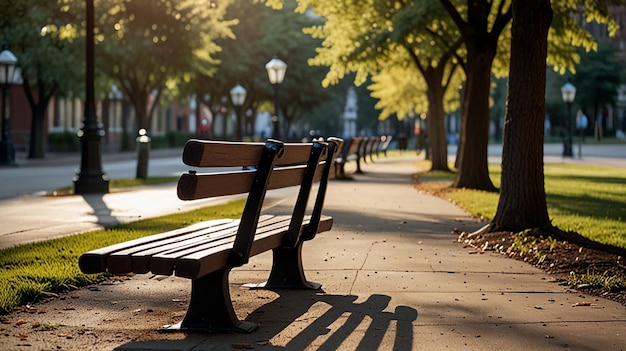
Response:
78,218,233,274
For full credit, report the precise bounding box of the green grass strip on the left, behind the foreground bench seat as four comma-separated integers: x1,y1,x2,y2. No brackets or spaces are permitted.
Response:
0,200,244,314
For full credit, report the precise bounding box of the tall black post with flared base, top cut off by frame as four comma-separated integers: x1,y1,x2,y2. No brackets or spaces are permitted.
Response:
74,0,109,194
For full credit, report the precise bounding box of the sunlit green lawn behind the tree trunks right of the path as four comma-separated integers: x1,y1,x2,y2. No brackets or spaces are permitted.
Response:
420,164,626,248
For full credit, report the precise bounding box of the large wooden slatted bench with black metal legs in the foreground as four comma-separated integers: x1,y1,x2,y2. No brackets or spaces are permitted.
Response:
79,138,343,332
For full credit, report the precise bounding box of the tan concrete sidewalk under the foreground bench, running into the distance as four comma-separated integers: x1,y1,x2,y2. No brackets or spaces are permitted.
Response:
0,156,626,350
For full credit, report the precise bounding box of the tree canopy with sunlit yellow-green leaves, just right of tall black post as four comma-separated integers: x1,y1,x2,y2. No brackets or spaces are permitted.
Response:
96,0,236,130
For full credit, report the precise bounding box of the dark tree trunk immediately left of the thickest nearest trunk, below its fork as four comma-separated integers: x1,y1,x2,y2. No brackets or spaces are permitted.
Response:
452,44,497,191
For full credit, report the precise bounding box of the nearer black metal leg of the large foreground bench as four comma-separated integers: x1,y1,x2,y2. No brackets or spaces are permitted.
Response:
163,268,257,333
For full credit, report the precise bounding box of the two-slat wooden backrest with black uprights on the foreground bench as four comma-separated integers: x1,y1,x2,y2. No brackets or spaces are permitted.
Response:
178,138,343,266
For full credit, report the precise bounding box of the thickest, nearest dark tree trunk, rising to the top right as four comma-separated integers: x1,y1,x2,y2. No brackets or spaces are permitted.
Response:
489,0,553,232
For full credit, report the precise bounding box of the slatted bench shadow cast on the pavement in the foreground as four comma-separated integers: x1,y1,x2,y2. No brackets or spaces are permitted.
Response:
116,290,418,350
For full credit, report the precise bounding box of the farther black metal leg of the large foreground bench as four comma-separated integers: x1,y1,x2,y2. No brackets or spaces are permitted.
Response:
245,242,322,290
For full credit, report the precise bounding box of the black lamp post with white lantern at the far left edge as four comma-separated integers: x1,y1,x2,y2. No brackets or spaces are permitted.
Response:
0,45,17,166
